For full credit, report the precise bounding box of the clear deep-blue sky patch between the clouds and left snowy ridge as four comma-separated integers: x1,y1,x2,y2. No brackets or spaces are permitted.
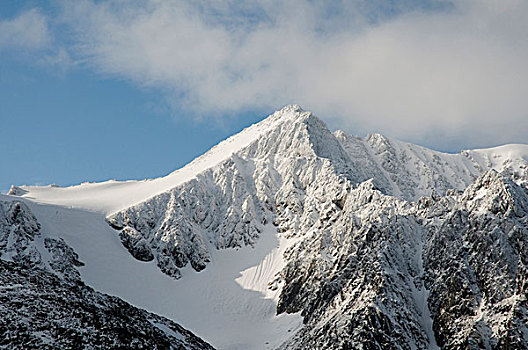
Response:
0,55,262,192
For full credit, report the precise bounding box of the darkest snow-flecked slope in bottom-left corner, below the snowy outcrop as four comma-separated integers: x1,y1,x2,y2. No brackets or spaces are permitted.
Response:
0,259,213,350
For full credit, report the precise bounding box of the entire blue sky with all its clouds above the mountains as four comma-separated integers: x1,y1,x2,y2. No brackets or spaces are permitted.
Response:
0,0,528,192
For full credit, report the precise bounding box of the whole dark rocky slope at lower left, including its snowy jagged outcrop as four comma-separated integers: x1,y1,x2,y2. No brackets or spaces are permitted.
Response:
0,201,213,350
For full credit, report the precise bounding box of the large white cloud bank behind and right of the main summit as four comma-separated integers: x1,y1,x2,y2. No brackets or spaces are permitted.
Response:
56,0,528,148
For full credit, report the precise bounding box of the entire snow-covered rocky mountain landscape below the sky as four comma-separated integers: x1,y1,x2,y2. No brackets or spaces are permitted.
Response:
0,105,528,350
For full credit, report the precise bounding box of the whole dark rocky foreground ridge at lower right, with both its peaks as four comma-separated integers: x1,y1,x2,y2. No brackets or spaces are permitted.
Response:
278,171,528,349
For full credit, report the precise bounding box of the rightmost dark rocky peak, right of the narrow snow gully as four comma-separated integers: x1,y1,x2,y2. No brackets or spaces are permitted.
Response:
424,170,528,349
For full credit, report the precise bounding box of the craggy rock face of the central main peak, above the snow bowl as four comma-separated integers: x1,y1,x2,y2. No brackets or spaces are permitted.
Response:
109,107,352,278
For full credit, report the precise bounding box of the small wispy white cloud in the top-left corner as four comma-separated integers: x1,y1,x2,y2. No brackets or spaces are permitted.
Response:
0,9,51,50
